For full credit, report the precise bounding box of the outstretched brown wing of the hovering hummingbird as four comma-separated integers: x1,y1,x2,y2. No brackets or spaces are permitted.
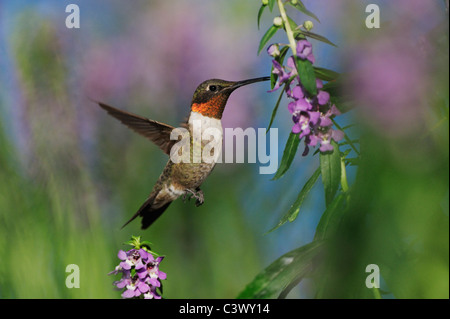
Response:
98,102,177,155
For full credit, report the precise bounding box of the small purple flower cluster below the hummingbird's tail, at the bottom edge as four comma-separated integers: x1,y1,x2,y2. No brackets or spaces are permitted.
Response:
109,238,167,299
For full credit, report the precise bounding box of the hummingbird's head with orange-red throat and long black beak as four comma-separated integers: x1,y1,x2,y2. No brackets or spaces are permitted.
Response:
191,77,270,119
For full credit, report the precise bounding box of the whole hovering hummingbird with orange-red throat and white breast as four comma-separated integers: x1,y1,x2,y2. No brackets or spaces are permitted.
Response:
98,77,270,229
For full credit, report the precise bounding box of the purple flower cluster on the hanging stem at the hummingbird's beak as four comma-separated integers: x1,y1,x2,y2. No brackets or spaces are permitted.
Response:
267,39,344,156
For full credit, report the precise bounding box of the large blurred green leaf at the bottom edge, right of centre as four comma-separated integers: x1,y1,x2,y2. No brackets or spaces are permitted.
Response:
237,241,322,299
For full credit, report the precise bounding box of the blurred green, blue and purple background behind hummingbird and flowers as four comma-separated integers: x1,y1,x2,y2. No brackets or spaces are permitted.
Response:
0,0,449,298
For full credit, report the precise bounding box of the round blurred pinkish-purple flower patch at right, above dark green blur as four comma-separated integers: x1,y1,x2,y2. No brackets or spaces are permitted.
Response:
351,35,427,135
